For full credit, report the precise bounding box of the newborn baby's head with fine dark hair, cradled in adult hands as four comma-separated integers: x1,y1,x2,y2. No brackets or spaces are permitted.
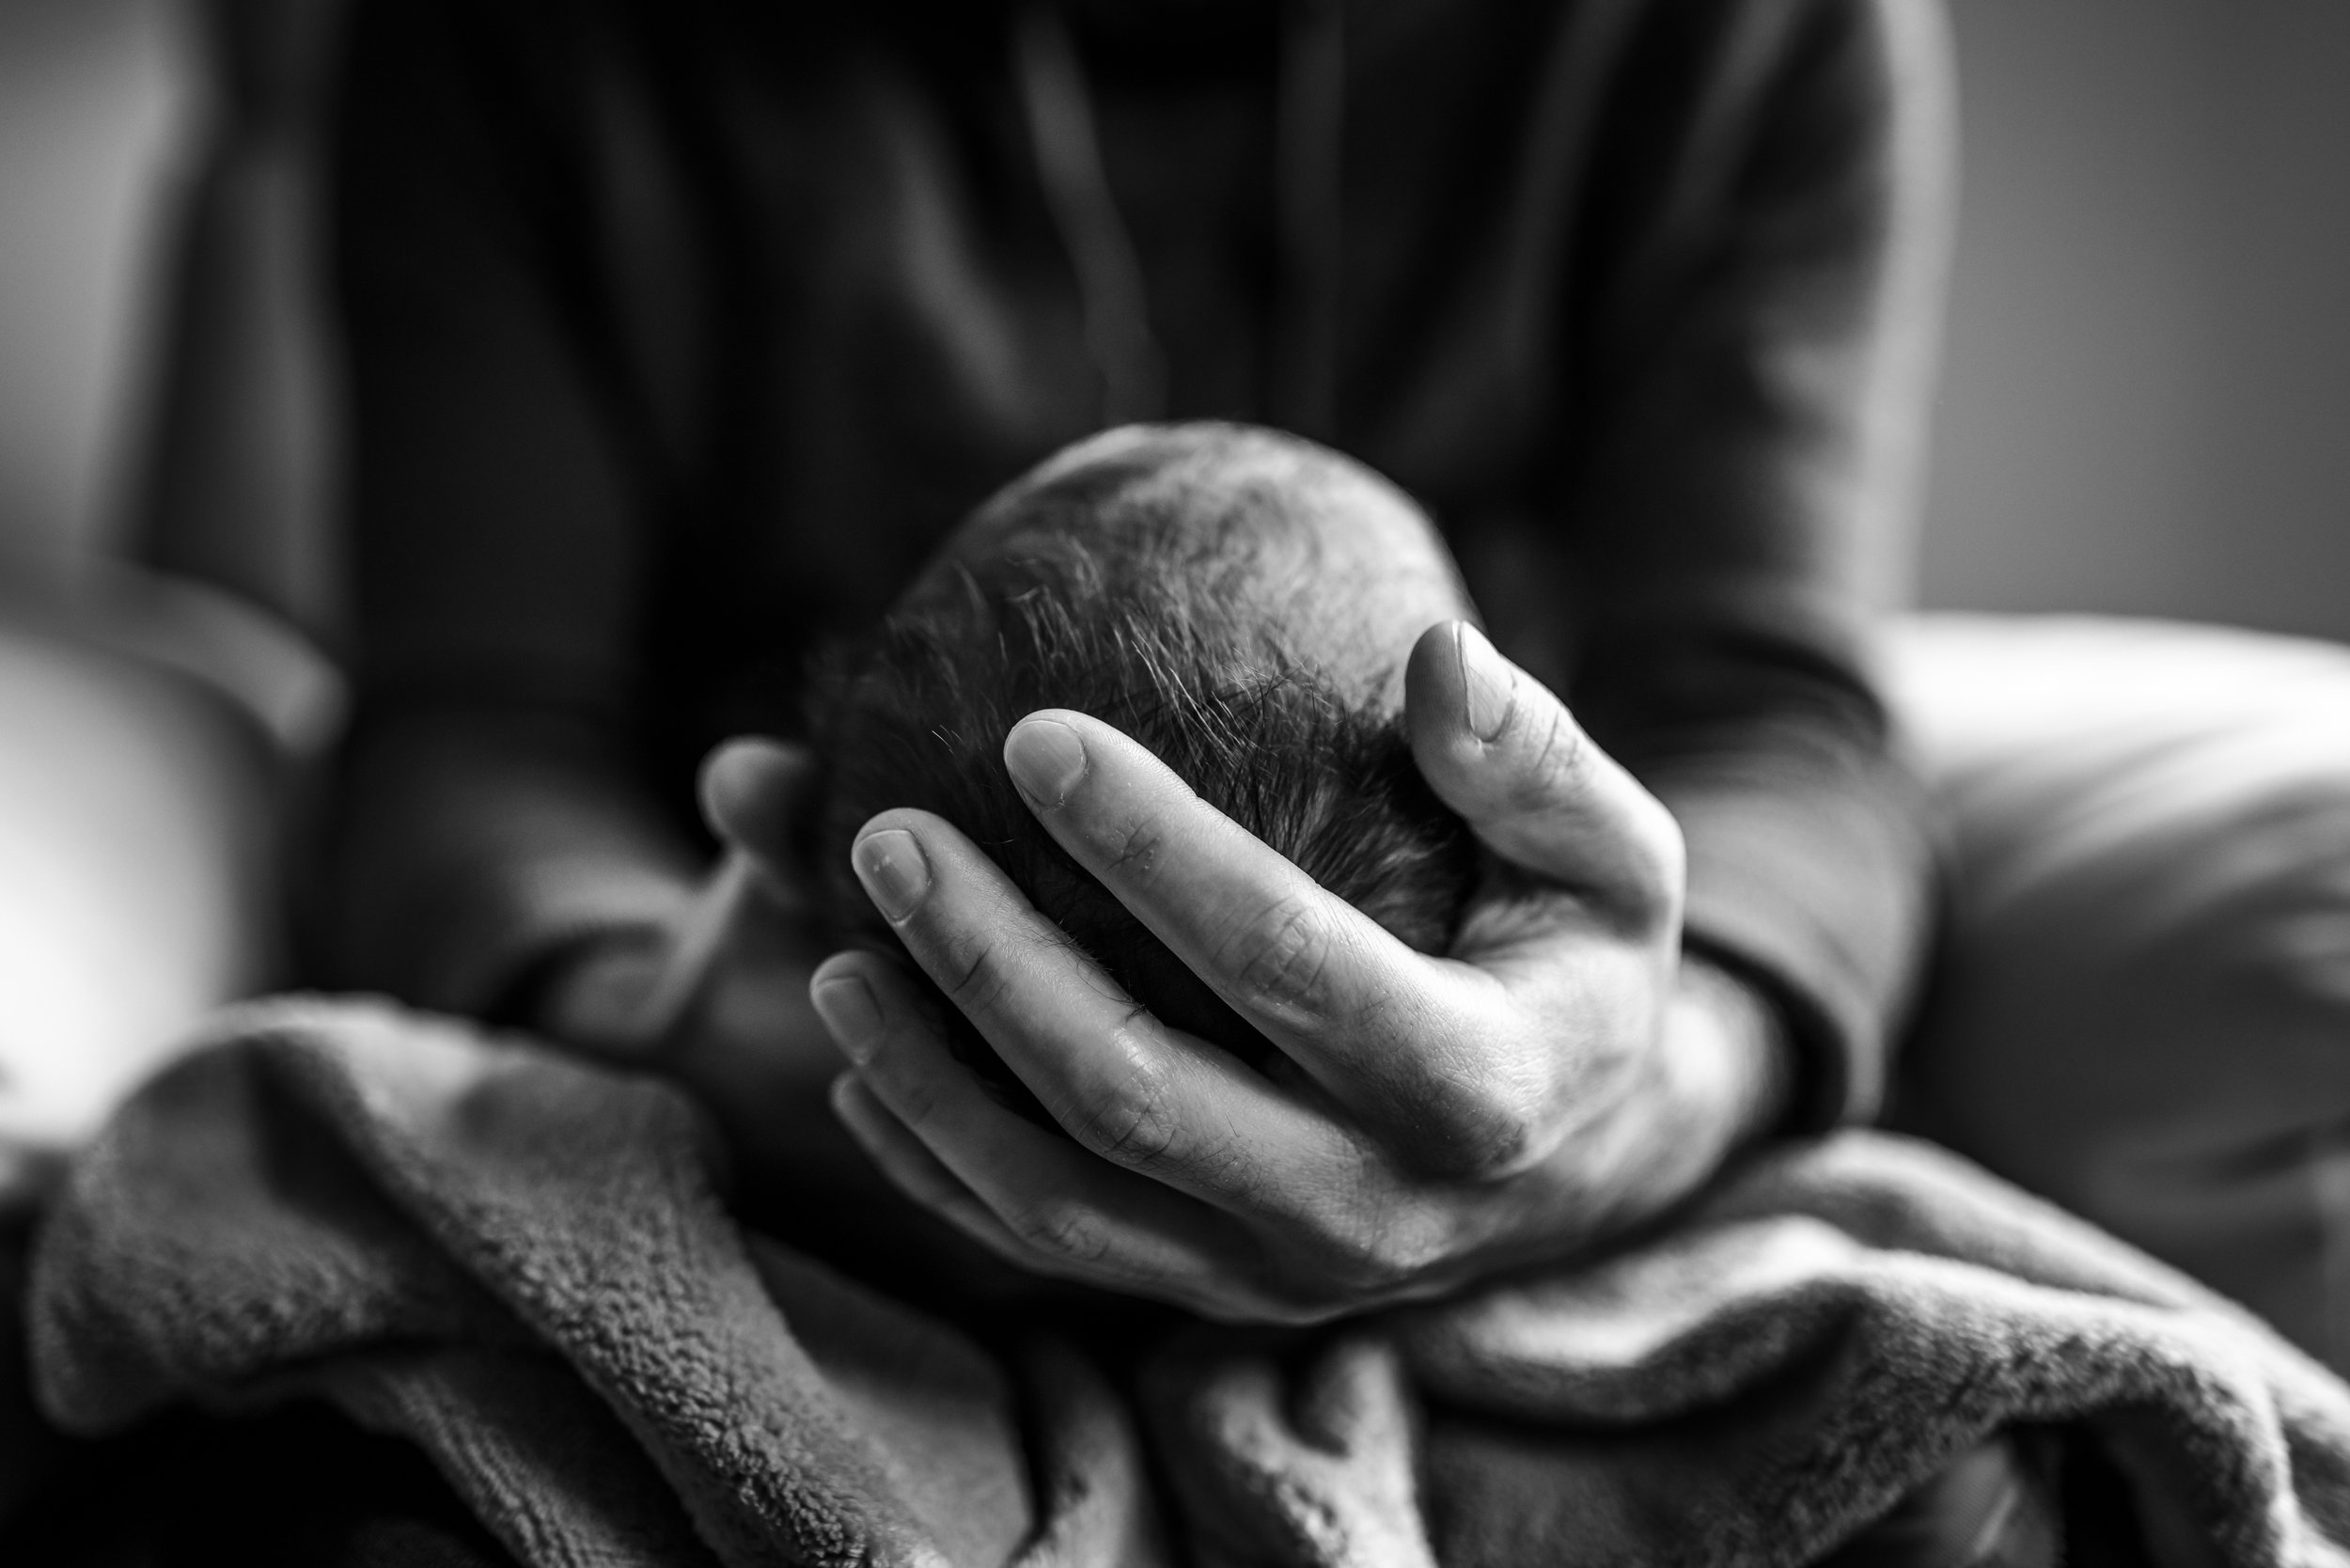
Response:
811,426,1476,1065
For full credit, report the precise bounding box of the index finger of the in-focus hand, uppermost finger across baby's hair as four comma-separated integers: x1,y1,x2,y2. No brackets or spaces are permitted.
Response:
1004,708,1485,1126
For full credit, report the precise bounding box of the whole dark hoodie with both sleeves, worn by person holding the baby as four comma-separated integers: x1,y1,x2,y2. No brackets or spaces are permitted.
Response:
327,0,1949,1121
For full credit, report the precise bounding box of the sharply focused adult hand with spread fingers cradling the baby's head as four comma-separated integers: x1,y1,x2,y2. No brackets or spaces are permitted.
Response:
813,623,1784,1321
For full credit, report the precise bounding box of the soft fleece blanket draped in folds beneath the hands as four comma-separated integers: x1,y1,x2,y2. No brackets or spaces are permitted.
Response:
28,999,2350,1568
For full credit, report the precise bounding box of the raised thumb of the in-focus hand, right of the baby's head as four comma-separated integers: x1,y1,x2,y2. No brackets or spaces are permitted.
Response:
1403,620,1685,924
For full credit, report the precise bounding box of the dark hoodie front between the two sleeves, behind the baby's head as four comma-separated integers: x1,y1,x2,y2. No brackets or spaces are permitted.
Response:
453,0,1734,750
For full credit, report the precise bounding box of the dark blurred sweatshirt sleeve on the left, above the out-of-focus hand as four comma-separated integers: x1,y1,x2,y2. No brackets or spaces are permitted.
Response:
318,0,696,1013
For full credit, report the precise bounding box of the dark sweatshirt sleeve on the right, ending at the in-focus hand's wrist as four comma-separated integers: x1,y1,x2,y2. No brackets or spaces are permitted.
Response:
1568,0,1953,1126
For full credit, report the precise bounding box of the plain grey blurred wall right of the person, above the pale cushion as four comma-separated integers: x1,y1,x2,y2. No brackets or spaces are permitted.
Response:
1922,0,2350,639
